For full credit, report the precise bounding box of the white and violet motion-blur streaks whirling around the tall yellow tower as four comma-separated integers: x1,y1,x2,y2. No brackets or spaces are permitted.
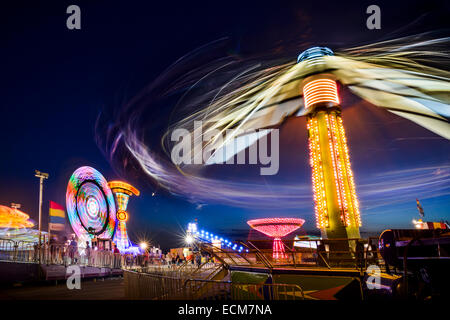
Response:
97,34,450,208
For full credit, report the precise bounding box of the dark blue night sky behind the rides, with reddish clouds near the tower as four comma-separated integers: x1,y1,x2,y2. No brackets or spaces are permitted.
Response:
0,1,450,248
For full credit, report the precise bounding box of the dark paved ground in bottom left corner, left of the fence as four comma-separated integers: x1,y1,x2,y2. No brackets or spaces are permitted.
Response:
0,278,124,300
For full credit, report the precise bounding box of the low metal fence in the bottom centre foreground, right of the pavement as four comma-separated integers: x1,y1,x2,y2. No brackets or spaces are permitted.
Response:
124,270,304,300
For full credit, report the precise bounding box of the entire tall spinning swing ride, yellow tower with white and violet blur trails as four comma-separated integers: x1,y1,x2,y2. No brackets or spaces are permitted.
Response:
102,35,450,244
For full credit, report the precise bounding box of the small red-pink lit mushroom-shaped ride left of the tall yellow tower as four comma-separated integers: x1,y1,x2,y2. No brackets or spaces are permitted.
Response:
247,218,305,259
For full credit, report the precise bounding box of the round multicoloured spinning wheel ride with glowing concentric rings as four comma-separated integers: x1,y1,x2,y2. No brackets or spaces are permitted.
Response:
66,166,116,241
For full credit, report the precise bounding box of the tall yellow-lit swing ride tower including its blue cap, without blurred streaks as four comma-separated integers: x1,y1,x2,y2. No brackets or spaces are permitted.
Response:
297,47,361,239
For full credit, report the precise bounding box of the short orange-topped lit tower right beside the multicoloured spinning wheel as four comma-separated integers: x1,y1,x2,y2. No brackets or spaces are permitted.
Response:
108,181,140,252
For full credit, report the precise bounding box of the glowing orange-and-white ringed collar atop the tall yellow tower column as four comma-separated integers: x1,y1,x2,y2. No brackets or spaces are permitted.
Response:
303,79,339,108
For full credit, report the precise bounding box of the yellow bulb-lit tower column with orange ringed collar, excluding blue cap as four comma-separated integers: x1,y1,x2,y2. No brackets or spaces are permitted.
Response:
303,78,361,230
